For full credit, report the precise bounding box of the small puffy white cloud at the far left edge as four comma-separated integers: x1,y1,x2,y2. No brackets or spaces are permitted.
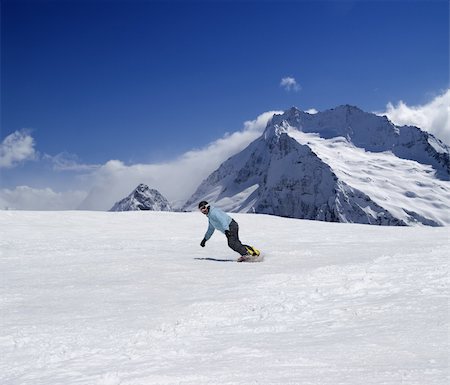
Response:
0,130,36,168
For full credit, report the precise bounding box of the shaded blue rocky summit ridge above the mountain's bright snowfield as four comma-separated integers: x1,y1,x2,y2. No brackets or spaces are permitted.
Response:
276,105,450,181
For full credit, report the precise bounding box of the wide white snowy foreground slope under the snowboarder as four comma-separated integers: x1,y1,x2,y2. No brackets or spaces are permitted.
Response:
0,211,450,385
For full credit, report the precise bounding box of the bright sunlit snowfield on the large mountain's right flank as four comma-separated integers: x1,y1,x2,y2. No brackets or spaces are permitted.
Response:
290,130,450,226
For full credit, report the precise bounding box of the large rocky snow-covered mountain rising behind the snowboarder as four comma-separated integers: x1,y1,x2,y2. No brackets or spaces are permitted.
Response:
184,106,450,226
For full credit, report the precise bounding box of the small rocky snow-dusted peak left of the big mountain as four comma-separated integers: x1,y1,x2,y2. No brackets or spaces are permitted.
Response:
109,183,173,211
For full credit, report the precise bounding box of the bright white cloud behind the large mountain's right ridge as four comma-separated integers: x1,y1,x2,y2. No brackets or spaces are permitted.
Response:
378,89,450,145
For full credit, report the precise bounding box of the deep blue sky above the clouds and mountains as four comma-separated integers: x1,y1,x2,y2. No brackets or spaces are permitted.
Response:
1,0,449,163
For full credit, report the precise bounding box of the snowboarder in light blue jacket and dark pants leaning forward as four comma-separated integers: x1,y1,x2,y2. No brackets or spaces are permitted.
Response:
198,201,260,262
